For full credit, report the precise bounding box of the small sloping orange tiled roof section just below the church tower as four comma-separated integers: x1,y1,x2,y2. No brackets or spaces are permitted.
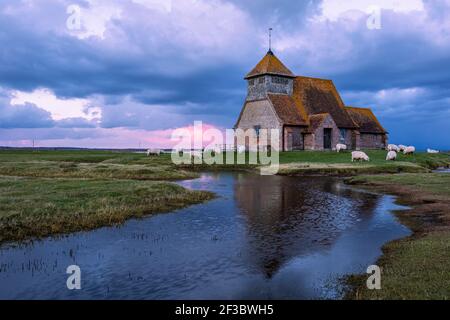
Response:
268,94,308,126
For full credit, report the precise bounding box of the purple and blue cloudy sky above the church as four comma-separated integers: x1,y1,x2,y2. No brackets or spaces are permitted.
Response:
0,0,450,149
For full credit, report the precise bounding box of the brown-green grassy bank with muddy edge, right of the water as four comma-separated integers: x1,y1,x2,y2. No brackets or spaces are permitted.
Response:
349,173,450,300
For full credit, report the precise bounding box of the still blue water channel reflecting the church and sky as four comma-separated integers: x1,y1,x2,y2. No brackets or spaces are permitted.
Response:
0,173,410,299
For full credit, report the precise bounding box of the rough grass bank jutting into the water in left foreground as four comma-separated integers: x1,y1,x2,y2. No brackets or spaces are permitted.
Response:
0,177,213,243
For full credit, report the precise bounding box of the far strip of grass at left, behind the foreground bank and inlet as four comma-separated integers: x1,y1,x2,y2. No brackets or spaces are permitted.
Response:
0,150,198,180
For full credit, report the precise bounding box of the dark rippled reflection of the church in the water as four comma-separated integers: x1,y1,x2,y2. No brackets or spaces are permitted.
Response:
234,175,379,278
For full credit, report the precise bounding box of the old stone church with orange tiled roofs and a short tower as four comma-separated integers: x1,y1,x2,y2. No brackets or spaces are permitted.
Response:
235,50,387,151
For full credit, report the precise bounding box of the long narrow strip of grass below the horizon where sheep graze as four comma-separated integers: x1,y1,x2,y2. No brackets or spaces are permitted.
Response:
0,150,450,180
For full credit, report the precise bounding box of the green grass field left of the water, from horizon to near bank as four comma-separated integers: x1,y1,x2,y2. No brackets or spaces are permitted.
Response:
0,150,213,243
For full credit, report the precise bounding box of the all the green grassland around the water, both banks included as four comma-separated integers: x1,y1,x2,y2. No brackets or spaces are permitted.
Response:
0,150,450,299
